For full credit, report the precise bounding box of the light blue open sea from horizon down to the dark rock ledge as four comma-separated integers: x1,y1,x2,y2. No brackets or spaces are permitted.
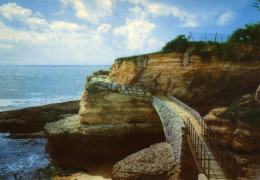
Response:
0,66,110,112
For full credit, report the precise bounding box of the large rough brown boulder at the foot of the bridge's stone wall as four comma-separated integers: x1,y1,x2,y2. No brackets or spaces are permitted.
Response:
112,143,178,180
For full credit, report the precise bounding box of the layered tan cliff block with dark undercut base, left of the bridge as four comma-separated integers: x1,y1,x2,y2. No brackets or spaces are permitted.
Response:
45,73,165,169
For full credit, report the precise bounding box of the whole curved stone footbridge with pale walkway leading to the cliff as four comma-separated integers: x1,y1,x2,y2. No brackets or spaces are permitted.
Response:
153,95,236,180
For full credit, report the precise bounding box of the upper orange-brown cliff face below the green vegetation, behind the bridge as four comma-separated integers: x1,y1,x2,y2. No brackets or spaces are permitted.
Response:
109,52,260,114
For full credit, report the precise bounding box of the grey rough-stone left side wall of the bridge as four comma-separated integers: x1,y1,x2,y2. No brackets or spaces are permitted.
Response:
153,97,183,162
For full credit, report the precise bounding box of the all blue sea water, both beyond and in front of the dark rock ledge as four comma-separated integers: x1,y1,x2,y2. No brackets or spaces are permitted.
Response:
0,65,110,180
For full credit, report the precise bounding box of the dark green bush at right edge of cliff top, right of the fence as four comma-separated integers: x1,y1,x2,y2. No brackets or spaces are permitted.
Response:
227,22,260,46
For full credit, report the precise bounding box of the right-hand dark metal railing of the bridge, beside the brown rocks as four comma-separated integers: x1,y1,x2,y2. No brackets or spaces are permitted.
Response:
203,121,237,180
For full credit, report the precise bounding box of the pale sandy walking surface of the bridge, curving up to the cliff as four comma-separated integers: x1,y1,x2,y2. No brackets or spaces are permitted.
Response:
156,96,227,180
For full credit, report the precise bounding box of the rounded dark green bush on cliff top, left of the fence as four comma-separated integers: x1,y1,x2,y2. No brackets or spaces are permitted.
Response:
162,35,189,53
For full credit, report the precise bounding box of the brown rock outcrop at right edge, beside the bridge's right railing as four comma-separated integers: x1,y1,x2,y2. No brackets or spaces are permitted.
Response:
204,94,260,152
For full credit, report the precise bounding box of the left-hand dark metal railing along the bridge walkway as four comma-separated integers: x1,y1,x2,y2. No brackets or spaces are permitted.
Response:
187,118,211,179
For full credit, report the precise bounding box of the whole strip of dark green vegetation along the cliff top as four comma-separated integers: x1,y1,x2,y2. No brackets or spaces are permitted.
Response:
116,22,260,62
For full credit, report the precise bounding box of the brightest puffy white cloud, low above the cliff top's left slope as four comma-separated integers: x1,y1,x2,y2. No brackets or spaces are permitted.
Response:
114,18,156,50
